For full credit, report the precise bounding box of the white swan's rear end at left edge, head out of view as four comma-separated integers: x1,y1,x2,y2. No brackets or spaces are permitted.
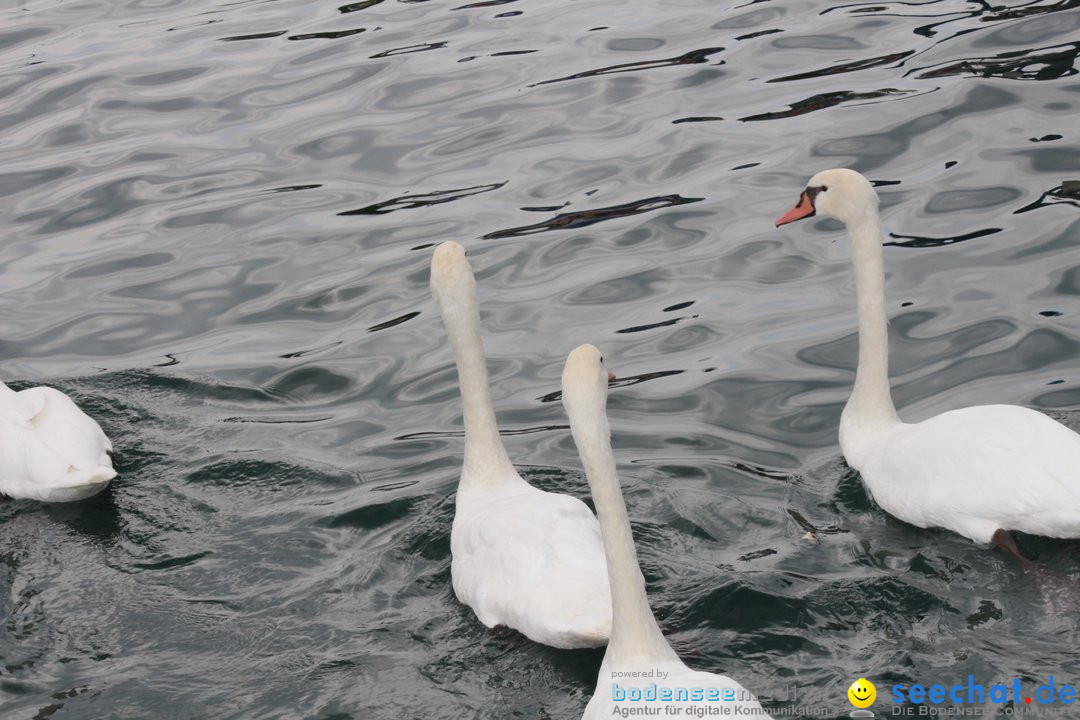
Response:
0,382,117,502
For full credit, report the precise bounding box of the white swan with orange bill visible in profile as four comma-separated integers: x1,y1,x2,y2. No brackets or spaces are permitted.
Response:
777,168,1080,568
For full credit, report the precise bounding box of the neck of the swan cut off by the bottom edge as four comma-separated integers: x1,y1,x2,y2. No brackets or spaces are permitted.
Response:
570,409,675,670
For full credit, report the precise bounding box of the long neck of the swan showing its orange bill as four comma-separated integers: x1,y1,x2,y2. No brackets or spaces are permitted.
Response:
845,208,899,424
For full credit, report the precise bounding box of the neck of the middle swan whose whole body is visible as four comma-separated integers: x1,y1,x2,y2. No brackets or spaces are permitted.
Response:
442,287,515,485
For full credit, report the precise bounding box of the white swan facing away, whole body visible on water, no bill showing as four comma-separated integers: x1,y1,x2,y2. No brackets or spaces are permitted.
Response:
431,242,611,648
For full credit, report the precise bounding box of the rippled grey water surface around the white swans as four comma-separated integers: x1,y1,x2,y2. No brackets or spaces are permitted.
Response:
0,0,1080,720
